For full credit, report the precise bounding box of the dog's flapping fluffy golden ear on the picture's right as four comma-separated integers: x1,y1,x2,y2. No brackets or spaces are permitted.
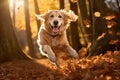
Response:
61,10,78,22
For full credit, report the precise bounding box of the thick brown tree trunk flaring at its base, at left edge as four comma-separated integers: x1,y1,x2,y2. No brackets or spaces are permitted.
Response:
0,0,29,62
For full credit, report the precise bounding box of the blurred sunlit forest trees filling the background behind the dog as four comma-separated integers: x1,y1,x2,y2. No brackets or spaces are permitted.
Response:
0,0,120,62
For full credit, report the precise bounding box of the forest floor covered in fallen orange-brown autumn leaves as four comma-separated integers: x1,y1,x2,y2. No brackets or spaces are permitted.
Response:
0,51,120,80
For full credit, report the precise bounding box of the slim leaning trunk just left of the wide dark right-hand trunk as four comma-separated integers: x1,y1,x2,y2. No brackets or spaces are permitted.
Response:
78,0,92,46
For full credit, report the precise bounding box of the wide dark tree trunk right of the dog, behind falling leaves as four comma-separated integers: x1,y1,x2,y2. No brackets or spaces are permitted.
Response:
89,0,109,56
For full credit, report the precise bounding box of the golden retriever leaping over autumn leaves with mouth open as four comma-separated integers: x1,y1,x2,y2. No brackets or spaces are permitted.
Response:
36,10,79,65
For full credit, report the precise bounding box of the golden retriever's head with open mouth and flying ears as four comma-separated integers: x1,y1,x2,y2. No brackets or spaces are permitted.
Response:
36,10,78,35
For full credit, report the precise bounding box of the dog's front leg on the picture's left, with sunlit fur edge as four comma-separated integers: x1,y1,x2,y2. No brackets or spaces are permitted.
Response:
40,45,56,63
